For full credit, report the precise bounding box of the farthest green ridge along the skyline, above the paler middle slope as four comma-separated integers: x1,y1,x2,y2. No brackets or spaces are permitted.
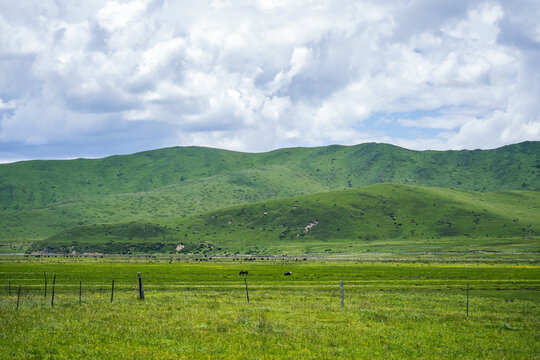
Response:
0,142,540,210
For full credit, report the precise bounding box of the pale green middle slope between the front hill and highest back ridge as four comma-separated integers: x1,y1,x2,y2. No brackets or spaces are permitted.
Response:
0,167,327,239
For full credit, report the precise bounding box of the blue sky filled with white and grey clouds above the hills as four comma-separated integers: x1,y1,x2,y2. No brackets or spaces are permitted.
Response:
0,0,540,163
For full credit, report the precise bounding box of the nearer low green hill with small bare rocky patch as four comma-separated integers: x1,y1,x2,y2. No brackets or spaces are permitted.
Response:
31,184,540,255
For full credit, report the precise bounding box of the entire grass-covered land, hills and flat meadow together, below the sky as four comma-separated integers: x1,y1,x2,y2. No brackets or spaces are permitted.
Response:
0,142,540,359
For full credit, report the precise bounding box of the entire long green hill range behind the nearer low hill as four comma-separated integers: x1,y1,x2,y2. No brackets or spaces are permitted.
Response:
0,142,540,248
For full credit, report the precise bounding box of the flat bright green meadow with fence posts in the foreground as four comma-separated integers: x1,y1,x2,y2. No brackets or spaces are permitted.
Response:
0,256,540,359
